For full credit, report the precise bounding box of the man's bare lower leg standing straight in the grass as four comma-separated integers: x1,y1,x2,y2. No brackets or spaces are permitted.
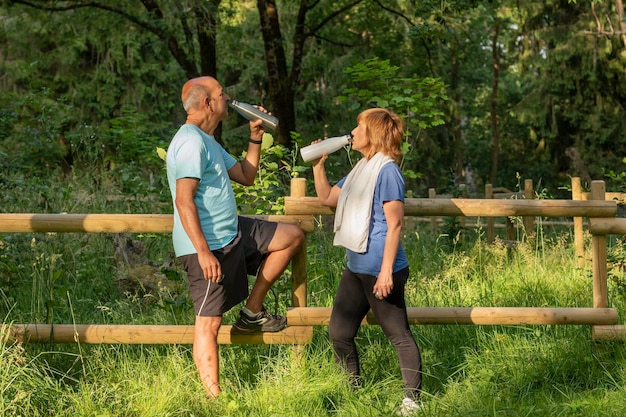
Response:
193,316,222,398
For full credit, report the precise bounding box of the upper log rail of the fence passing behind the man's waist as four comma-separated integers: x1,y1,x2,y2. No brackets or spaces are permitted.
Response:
0,213,315,233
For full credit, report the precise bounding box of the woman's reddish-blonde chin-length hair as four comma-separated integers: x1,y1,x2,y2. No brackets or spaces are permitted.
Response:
356,108,404,162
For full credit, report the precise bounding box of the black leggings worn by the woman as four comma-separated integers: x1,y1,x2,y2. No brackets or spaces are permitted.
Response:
328,268,422,399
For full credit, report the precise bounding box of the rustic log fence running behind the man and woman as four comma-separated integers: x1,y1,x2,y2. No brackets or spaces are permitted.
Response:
0,178,626,344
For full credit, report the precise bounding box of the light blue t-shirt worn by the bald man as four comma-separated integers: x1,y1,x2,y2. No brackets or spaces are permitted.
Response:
166,124,238,256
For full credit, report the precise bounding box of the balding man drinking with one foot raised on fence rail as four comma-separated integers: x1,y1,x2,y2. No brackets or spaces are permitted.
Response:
167,77,304,398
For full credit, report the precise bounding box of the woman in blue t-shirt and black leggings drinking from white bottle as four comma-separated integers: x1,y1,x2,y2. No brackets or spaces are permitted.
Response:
313,108,422,415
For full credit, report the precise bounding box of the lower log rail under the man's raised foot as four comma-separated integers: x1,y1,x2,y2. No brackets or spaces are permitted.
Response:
6,324,313,344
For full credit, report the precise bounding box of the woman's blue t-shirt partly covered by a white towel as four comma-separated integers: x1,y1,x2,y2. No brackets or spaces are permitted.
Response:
337,163,409,276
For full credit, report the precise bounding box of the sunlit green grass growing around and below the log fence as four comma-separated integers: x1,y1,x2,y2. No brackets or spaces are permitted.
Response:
0,170,626,417
